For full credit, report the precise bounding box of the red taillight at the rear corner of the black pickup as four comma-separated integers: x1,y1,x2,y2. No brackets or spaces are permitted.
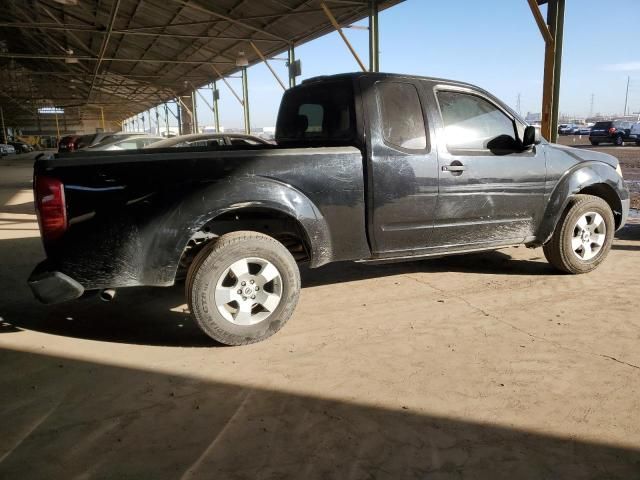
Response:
34,176,67,240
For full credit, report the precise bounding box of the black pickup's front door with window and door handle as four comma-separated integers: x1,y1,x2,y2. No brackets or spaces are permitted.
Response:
431,86,546,250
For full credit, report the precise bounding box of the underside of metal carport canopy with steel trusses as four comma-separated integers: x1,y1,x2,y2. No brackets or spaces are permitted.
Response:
0,0,403,125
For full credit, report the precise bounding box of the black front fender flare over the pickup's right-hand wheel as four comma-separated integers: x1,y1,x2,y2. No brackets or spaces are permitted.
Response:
533,161,628,246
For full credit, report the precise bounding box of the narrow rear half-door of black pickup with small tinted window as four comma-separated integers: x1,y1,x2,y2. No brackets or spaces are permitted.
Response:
360,77,438,256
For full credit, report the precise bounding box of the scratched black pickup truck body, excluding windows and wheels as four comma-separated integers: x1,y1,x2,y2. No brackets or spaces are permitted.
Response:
30,73,629,303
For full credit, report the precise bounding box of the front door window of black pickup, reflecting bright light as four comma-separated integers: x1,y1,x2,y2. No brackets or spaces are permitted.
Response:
437,91,516,151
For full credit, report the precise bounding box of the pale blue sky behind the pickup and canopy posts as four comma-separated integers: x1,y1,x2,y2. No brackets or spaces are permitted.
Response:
130,0,640,128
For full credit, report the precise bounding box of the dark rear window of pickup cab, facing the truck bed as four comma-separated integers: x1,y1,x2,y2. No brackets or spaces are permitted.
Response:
276,80,356,145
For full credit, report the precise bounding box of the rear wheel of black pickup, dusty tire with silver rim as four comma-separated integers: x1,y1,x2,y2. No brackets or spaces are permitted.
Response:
185,231,300,345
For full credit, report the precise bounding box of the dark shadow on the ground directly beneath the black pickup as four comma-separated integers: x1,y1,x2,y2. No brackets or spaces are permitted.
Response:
0,234,555,347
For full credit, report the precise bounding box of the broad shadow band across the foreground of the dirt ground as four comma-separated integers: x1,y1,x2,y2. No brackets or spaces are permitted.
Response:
0,350,640,480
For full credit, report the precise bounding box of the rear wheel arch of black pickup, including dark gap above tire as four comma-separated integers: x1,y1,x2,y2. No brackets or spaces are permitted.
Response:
141,176,333,285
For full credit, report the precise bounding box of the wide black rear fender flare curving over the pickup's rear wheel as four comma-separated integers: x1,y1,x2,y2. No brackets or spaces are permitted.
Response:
142,176,333,285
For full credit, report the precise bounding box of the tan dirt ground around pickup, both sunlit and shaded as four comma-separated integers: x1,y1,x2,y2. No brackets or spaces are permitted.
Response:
0,147,640,480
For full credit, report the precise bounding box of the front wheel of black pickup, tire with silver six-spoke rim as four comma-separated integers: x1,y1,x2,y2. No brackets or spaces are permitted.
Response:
543,195,615,274
